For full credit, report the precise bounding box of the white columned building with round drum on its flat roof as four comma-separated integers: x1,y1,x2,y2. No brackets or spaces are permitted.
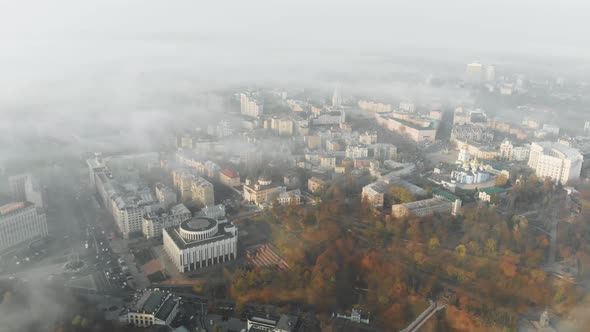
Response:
162,216,238,272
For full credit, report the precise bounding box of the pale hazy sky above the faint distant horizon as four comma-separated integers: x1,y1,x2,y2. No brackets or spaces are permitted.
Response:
0,0,590,53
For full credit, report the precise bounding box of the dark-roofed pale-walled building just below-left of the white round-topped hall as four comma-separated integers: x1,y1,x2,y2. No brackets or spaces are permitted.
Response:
119,290,179,327
